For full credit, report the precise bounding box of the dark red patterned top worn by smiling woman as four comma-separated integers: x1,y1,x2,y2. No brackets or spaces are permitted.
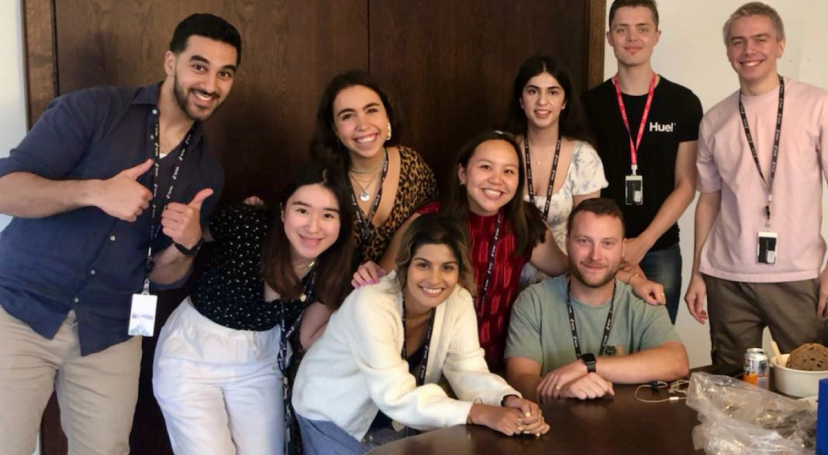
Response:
417,202,530,372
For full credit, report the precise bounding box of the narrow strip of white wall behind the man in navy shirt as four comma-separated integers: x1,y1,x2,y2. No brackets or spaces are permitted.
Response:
0,0,26,230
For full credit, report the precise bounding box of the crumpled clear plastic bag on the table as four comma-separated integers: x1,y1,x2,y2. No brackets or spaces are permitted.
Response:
687,373,816,455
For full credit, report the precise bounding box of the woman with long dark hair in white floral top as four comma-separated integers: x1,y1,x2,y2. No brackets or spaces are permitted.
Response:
508,55,608,287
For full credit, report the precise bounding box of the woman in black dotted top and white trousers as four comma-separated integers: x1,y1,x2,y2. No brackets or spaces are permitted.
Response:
153,164,353,455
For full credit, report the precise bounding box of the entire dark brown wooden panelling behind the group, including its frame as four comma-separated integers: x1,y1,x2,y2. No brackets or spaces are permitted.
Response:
21,0,606,455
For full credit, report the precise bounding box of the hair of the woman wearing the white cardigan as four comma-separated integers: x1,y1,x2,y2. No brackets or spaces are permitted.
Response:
395,213,475,295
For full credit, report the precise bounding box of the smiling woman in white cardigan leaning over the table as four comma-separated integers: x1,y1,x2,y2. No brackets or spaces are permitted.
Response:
294,214,549,455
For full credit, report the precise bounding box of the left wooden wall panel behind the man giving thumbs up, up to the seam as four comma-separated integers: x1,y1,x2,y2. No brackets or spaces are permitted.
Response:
55,0,368,205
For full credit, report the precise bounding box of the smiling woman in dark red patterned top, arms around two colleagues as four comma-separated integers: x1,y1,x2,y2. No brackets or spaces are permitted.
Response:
352,131,660,372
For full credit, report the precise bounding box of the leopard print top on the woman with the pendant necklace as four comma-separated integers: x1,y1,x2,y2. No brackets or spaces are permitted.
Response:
354,146,437,264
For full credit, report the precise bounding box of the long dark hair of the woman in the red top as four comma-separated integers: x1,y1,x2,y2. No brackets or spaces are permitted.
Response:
440,131,546,255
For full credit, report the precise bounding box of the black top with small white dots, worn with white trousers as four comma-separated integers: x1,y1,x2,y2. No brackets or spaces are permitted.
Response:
191,204,313,331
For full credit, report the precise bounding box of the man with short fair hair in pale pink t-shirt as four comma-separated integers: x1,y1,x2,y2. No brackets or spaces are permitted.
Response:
685,2,828,364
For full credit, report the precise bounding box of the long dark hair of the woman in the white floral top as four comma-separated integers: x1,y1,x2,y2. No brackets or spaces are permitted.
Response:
506,55,592,143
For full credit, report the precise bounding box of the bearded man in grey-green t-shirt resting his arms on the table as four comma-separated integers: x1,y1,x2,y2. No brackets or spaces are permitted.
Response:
506,198,688,402
